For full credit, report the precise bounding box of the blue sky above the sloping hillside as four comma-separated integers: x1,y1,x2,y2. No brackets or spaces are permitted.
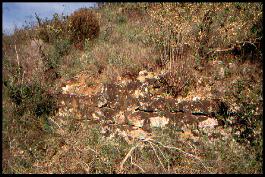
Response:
2,2,96,34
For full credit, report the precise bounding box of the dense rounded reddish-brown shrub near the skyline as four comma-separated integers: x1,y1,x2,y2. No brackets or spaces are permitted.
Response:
68,8,100,46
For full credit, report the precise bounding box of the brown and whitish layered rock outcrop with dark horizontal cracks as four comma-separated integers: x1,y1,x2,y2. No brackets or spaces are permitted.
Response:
54,71,238,142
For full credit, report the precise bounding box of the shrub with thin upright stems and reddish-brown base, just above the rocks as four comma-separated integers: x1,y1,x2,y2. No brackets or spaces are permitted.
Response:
155,32,195,97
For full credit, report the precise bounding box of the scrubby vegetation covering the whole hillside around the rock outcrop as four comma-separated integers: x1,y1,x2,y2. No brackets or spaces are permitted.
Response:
2,2,263,173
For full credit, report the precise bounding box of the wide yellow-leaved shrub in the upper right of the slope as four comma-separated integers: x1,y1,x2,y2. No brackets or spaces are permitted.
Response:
147,3,262,61
